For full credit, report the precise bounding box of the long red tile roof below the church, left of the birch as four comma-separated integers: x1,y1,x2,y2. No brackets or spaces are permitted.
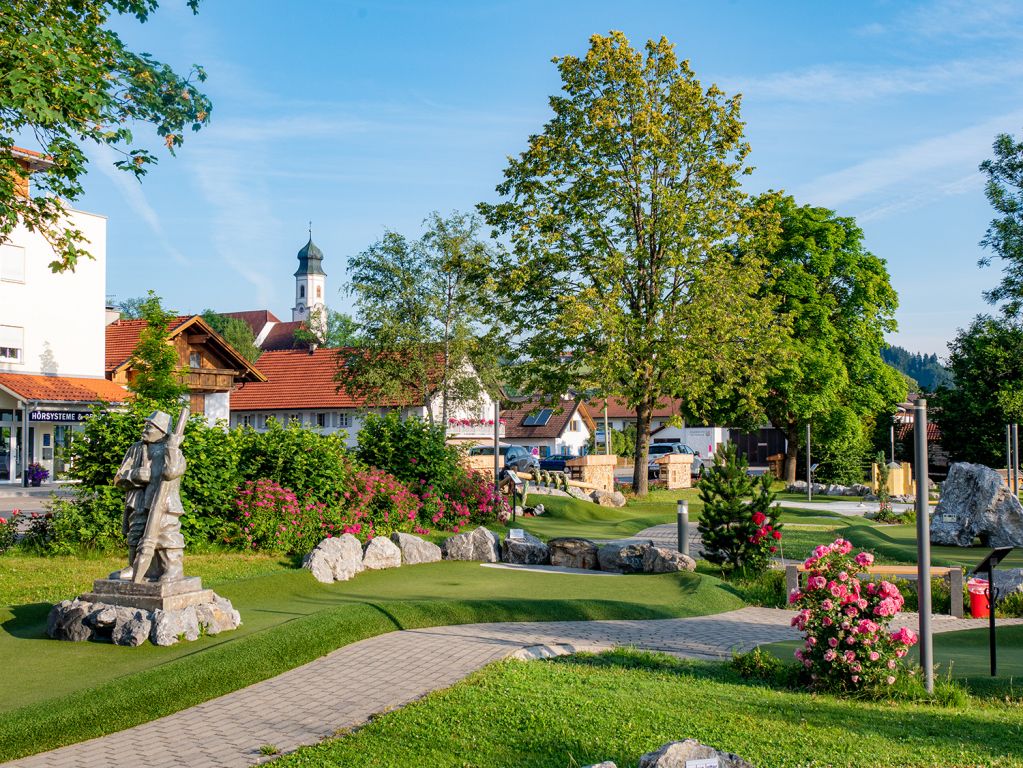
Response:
231,349,407,412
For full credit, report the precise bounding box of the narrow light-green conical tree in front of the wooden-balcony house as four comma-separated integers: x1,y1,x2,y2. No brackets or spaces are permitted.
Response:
128,290,188,410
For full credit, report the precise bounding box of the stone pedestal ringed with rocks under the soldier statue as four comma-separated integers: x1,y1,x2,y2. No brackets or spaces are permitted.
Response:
46,577,241,645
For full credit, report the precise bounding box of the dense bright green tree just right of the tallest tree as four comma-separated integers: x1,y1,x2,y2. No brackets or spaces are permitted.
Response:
761,192,906,482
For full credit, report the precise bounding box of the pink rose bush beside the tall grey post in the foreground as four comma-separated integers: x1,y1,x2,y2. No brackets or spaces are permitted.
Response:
789,539,917,690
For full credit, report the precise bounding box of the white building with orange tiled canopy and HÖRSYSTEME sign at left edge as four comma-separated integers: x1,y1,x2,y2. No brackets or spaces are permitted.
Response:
0,148,127,482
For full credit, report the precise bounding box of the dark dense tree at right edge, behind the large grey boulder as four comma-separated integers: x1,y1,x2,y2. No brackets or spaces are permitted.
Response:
932,315,1023,466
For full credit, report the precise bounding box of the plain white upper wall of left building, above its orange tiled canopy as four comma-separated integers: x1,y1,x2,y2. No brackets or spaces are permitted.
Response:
0,211,106,378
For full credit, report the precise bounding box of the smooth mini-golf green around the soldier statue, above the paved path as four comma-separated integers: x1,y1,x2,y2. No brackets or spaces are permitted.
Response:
0,554,743,762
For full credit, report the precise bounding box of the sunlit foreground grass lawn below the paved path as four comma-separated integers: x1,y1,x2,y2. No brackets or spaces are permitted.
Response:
274,651,1023,768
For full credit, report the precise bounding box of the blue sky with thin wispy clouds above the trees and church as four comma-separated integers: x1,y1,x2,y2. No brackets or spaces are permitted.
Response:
79,0,1023,355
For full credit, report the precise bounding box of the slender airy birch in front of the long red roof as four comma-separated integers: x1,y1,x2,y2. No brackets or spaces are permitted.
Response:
337,213,494,426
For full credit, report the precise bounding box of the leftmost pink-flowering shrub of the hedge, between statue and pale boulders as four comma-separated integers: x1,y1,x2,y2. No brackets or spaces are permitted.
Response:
234,479,304,552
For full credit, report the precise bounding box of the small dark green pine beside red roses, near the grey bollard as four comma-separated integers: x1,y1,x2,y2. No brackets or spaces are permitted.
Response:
699,443,782,573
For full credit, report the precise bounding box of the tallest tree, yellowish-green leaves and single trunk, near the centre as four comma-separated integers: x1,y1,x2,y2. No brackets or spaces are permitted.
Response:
480,32,776,494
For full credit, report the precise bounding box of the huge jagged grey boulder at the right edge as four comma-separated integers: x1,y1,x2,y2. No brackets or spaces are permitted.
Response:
931,462,1023,547
